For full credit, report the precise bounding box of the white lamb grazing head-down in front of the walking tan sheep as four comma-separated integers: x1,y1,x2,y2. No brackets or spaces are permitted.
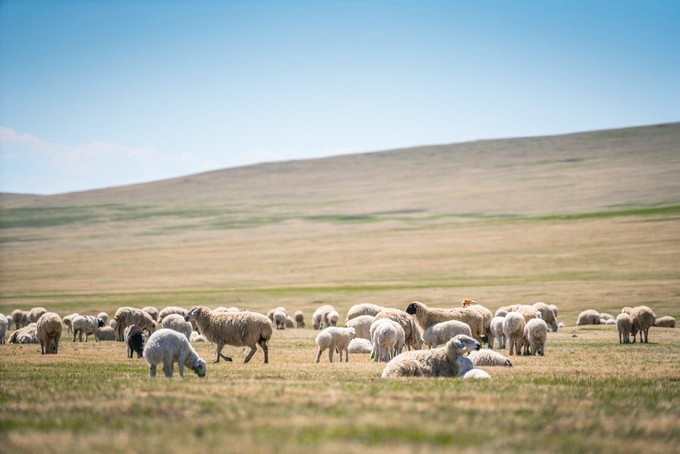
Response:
143,328,207,378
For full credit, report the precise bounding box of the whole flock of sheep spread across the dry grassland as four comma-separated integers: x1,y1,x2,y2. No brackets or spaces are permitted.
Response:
0,299,675,378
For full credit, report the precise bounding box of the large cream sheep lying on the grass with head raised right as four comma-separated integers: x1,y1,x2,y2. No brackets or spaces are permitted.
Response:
382,334,481,378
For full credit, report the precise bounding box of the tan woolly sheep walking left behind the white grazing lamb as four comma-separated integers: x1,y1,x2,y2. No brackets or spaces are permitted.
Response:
184,306,274,364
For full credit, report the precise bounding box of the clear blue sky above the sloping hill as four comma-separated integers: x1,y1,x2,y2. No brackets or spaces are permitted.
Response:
0,0,680,194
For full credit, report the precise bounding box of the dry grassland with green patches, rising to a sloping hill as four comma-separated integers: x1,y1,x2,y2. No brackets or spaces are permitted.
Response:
0,124,680,453
